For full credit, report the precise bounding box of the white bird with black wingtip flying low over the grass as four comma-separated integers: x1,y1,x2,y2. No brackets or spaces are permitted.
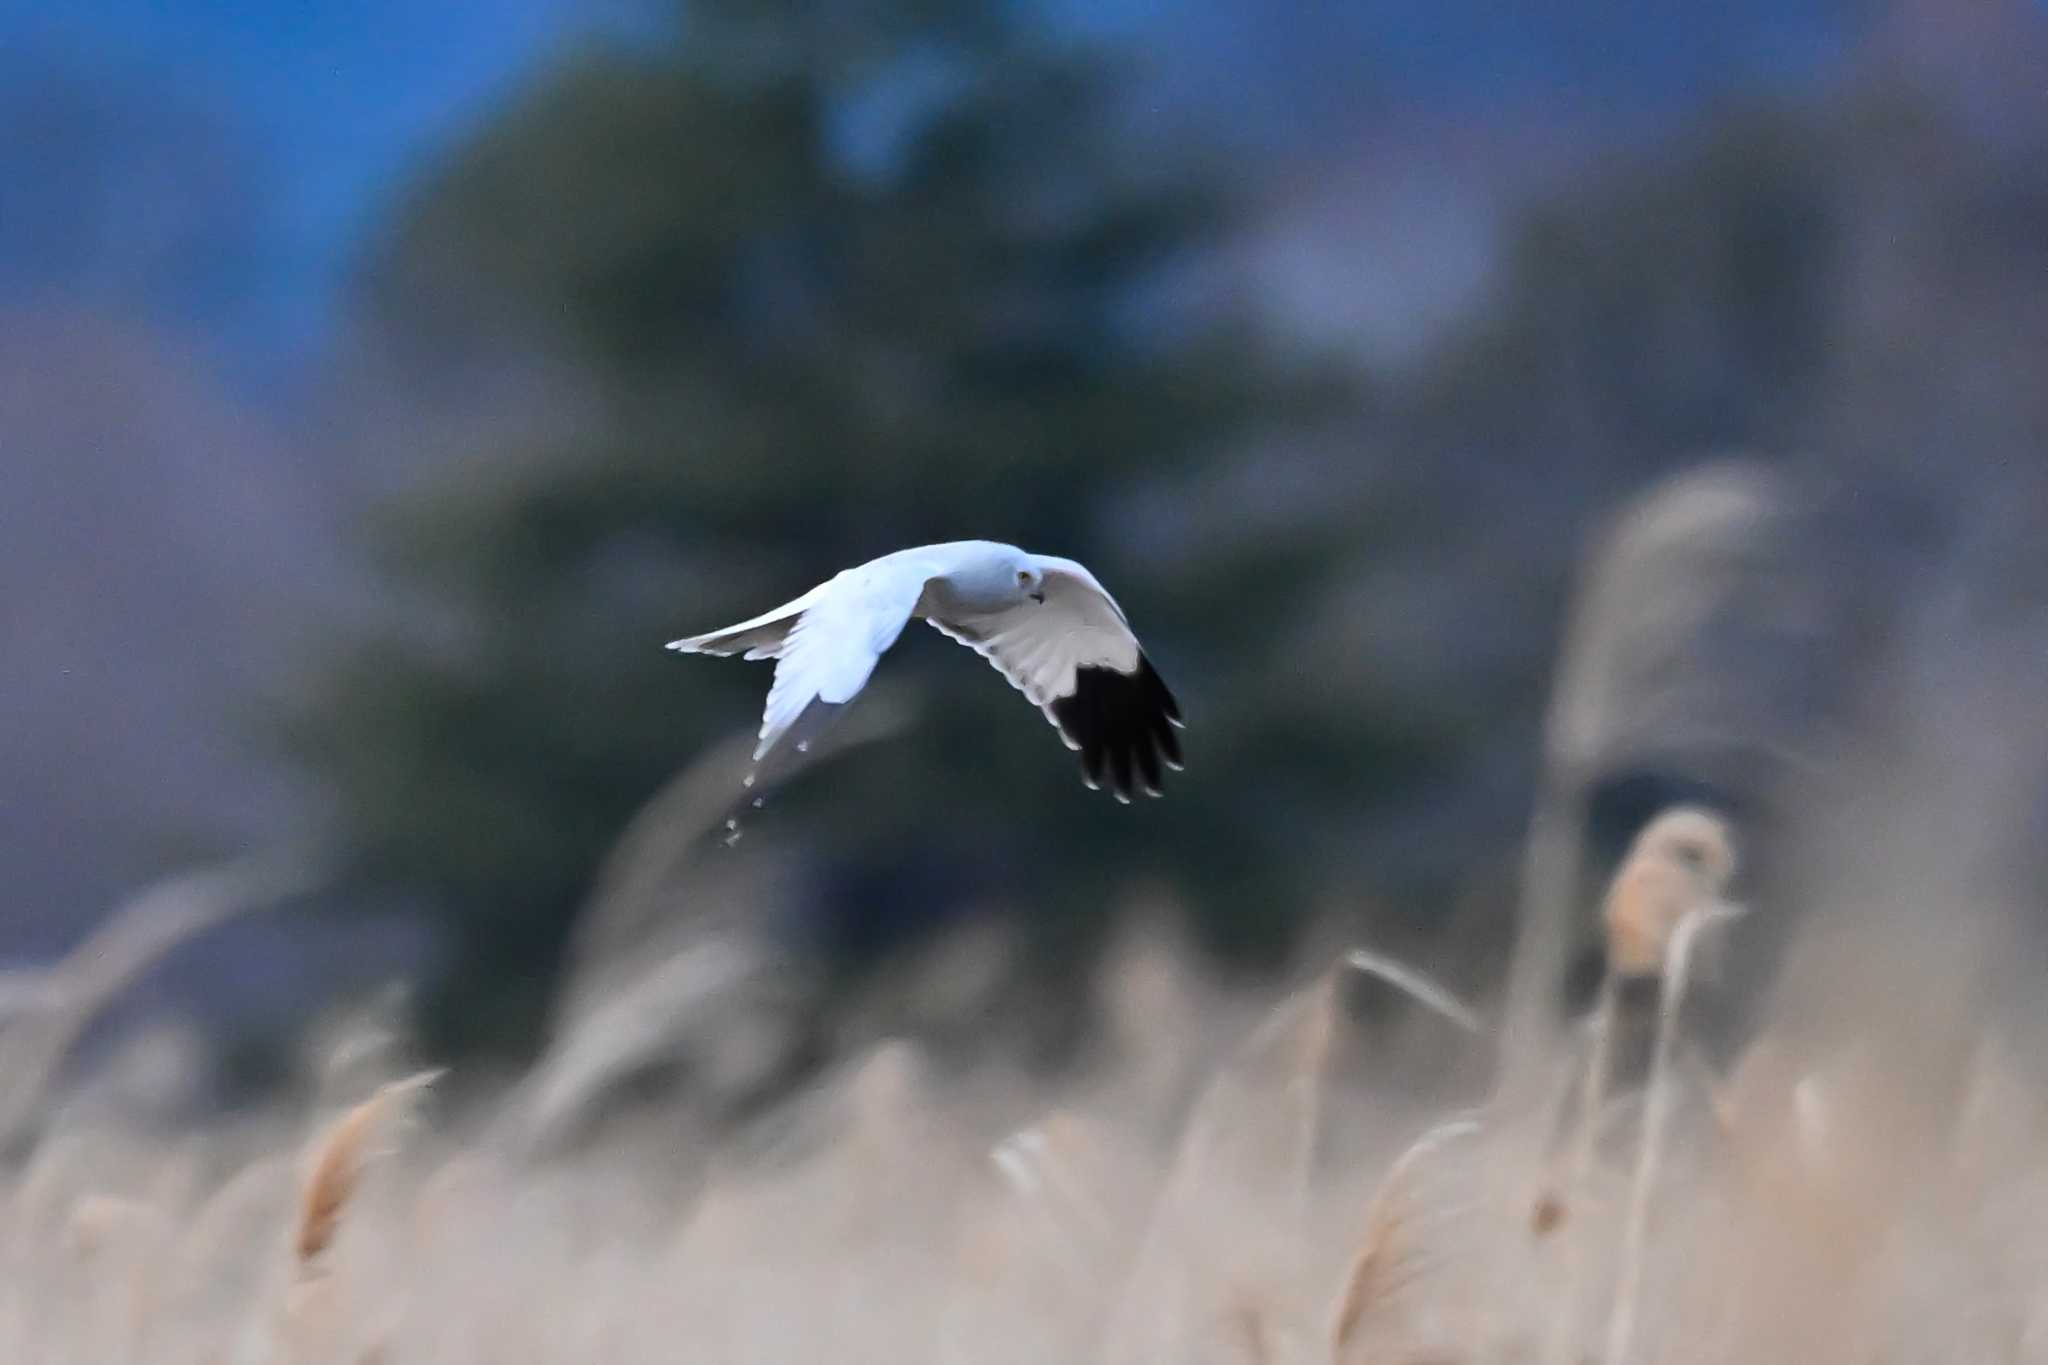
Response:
670,540,1182,802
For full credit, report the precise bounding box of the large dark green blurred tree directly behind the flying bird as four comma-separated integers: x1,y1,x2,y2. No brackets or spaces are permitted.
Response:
295,0,1376,1048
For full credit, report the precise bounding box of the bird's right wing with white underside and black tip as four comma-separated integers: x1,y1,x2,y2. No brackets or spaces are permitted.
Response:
928,555,1182,800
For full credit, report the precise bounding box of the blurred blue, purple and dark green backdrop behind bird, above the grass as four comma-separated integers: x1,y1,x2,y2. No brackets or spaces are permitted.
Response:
0,0,2048,1095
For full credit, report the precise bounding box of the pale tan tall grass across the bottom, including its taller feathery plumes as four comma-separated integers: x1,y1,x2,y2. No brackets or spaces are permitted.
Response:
0,467,2048,1365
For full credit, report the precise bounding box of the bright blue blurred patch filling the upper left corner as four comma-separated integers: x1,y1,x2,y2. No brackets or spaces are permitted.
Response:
0,0,622,379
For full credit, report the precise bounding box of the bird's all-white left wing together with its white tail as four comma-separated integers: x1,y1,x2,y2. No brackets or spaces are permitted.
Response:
670,559,928,763
